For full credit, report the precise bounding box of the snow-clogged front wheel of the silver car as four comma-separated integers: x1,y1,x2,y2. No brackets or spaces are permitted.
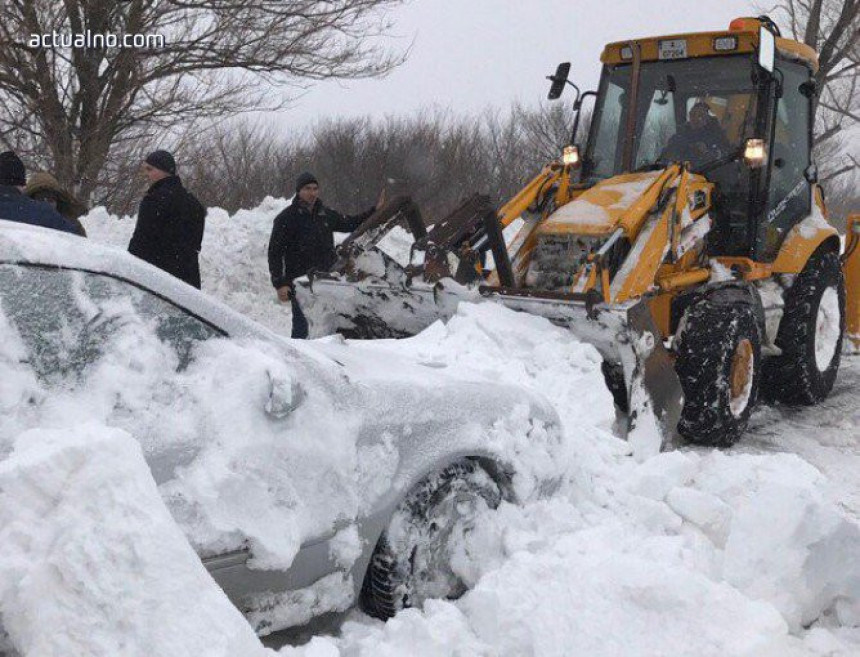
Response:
361,460,504,620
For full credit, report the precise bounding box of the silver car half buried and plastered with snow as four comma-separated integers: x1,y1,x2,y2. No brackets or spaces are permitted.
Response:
0,221,560,633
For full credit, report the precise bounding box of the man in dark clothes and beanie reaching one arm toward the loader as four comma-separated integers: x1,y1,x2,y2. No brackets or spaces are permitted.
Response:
269,172,384,338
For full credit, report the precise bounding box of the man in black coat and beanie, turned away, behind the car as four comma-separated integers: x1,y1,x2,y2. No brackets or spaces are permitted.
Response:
128,151,206,289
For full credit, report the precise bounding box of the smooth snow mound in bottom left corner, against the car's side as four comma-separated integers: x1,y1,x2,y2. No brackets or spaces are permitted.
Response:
0,424,271,657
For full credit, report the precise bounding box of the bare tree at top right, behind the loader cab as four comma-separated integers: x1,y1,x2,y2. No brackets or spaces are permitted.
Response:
776,0,860,182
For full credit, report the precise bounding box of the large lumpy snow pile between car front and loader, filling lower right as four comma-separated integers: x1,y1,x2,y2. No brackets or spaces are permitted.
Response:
304,304,860,656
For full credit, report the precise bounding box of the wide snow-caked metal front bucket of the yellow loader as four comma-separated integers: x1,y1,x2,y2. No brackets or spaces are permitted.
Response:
296,277,684,459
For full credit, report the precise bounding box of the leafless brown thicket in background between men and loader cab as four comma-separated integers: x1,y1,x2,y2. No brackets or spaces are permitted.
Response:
177,104,588,222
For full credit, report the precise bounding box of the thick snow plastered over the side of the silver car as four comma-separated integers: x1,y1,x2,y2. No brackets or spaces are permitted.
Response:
0,290,370,567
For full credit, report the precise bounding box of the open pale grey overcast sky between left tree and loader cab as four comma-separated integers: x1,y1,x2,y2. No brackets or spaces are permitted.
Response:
278,0,758,130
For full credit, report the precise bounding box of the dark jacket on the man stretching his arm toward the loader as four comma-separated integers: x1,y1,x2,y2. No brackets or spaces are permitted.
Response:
269,196,375,288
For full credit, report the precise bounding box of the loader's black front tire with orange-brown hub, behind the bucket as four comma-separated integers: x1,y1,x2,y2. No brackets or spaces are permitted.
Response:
675,300,761,447
